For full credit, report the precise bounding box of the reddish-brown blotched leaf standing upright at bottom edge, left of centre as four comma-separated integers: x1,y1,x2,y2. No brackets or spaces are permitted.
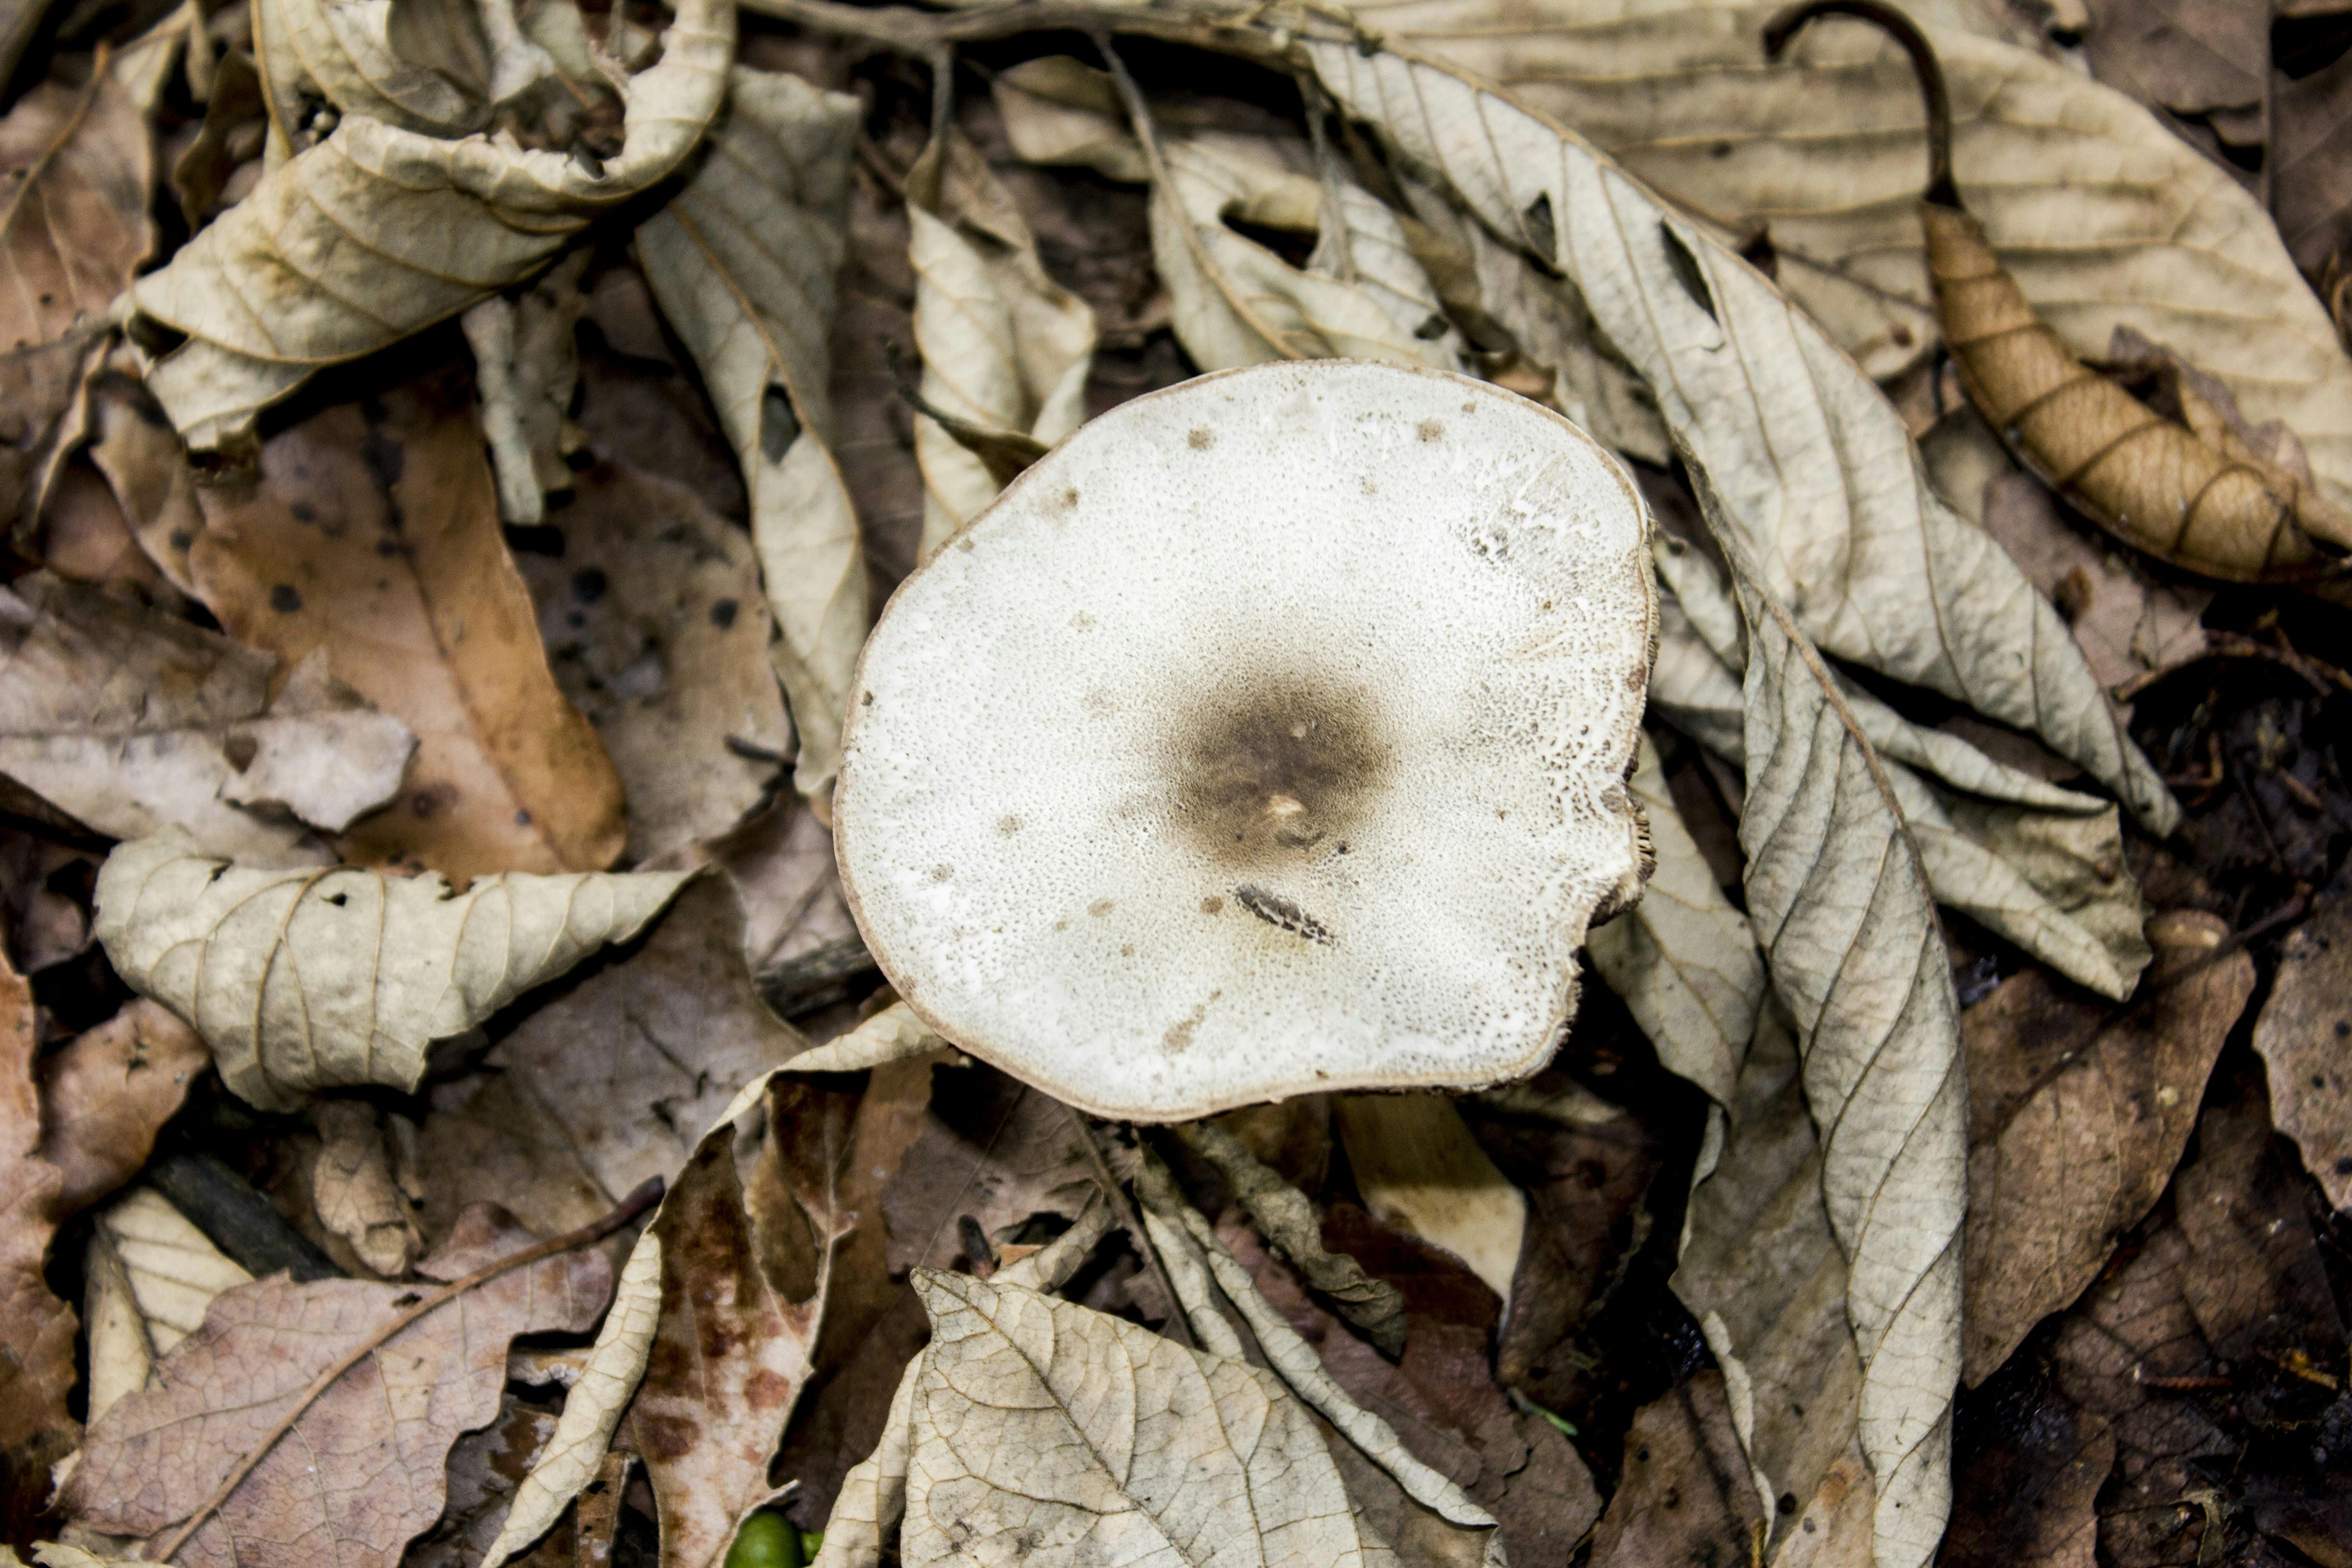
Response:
630,1072,856,1568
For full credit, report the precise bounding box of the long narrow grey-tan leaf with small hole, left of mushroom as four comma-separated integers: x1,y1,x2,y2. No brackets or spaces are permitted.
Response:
637,66,865,799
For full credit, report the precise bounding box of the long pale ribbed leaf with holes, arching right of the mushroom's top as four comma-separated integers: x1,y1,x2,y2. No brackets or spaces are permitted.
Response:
1301,37,2180,830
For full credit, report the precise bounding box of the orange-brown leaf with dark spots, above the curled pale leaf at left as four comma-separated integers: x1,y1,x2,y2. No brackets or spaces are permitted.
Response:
181,374,626,882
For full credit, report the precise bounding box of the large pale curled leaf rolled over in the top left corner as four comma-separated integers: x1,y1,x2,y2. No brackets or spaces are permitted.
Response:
132,0,734,449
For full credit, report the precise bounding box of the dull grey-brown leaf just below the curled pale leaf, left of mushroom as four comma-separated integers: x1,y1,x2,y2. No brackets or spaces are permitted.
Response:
485,875,807,1241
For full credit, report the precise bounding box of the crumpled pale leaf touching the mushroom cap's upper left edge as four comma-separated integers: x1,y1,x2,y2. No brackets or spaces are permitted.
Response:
906,127,1094,557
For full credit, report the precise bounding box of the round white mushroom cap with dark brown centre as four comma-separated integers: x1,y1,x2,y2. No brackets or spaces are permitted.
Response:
833,360,1658,1121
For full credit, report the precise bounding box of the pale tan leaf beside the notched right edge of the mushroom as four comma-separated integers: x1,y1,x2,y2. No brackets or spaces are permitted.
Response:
1585,733,1764,1105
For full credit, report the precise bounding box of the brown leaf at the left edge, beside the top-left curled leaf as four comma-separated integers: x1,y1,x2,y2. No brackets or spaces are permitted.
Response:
0,63,155,541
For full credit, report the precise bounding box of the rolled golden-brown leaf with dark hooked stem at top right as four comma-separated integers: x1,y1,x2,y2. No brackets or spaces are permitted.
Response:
1764,0,2352,583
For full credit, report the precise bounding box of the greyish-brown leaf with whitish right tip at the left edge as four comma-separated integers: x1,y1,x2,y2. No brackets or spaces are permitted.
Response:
0,571,416,865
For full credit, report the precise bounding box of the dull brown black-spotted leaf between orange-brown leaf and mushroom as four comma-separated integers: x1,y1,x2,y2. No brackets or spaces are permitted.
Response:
515,463,793,865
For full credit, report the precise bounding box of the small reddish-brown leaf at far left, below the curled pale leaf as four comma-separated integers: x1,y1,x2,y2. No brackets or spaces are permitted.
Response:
40,997,212,1218
